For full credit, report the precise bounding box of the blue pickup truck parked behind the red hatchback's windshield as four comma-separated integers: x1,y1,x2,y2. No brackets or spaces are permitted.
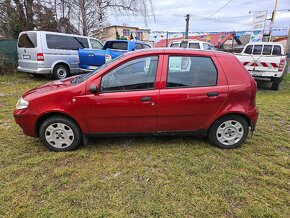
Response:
79,40,150,71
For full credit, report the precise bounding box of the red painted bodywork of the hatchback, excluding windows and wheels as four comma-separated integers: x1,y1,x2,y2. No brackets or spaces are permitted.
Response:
14,49,258,136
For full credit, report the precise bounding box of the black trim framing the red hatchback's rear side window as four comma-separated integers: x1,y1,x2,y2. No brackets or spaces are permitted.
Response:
165,54,219,89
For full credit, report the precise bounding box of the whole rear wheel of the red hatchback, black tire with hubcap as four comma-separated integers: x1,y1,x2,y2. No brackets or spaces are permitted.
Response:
208,115,249,149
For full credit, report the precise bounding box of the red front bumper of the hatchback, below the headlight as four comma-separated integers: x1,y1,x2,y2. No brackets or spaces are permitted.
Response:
13,109,37,137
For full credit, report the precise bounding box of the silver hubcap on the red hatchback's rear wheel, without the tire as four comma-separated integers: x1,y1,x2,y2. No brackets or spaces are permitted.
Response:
216,120,244,145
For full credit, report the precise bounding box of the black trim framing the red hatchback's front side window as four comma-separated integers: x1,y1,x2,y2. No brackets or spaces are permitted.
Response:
99,54,160,94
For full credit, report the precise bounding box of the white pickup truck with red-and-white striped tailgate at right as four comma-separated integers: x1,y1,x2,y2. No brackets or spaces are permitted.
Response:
235,42,287,90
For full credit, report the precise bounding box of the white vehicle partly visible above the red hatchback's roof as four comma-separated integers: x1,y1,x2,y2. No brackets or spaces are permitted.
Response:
168,40,216,51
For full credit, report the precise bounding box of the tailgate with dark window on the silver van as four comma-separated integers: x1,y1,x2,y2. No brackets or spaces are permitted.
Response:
17,32,42,68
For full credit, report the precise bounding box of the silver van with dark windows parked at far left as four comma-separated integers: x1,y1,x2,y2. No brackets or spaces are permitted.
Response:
17,31,103,79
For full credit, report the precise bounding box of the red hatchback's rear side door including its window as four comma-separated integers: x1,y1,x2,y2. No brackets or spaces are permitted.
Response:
157,55,228,132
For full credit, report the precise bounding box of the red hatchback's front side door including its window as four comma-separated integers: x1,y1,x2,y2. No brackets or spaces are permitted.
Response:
85,56,159,134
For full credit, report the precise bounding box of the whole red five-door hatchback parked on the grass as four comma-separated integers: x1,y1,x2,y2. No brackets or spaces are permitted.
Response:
14,48,258,151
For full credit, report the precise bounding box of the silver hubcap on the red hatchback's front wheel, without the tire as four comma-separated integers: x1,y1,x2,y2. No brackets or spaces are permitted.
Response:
45,123,74,148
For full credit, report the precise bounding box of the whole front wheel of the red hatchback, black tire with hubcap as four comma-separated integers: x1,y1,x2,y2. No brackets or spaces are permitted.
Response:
39,116,82,151
